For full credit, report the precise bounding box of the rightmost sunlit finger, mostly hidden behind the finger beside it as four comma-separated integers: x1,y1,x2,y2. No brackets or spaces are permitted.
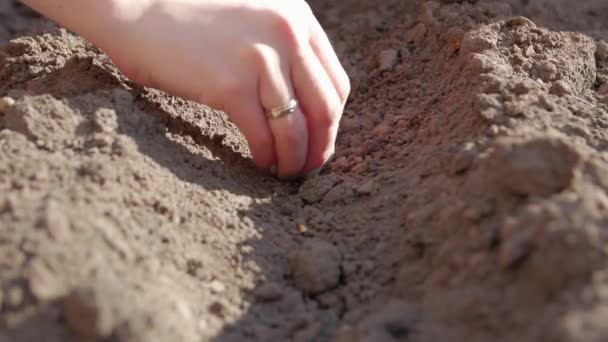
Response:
310,15,350,109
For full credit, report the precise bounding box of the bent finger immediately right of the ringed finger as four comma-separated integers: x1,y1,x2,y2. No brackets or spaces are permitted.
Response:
292,47,343,173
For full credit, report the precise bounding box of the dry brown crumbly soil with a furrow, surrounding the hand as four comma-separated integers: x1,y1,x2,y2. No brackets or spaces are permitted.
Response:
0,0,608,342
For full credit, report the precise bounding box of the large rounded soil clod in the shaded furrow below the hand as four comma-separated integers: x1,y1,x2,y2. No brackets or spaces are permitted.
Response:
291,239,342,295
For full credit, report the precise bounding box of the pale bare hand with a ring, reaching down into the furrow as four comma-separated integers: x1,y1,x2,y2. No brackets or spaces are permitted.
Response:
23,0,350,178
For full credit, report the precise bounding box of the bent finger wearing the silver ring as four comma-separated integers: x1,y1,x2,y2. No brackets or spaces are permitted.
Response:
258,47,309,178
